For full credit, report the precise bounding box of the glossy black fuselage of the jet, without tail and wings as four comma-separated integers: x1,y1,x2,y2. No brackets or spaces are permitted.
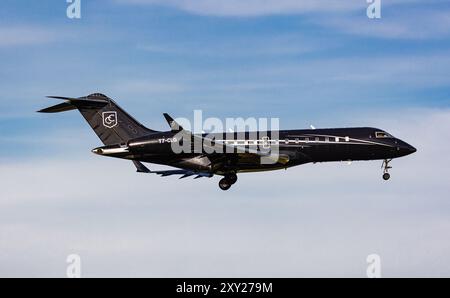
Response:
94,127,416,175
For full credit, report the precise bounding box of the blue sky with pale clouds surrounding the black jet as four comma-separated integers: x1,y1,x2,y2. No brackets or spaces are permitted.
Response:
0,0,450,276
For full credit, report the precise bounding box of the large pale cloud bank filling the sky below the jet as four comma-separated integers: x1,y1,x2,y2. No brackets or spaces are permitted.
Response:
0,110,450,277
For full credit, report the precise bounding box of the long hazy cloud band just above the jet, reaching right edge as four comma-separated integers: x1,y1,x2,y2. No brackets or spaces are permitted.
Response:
100,51,450,109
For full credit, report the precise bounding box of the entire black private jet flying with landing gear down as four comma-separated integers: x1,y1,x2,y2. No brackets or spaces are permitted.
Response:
39,93,416,190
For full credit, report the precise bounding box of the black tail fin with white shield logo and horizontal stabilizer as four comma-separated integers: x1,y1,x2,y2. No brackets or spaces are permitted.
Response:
38,93,155,145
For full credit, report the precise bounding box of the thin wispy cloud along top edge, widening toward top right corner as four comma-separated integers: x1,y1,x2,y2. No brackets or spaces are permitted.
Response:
116,0,450,39
